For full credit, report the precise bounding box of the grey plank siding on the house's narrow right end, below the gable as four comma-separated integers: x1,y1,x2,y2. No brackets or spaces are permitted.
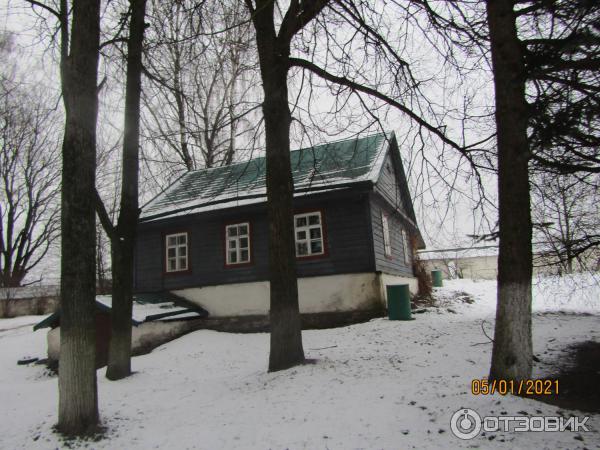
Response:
370,193,413,277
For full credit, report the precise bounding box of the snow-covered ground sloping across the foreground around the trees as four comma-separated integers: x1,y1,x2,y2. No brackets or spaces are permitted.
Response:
0,277,600,449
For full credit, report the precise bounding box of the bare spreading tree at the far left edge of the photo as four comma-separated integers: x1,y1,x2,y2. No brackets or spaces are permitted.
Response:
0,38,60,287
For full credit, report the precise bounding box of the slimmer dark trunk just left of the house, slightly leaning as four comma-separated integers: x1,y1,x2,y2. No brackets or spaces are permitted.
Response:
106,0,146,380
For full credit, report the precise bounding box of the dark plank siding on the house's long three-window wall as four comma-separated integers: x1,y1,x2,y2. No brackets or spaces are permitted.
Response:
135,192,375,292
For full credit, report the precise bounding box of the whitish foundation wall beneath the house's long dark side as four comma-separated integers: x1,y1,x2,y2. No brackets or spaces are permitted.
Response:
173,273,394,317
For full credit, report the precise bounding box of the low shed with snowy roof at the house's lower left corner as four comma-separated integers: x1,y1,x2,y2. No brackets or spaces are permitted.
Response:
33,292,208,367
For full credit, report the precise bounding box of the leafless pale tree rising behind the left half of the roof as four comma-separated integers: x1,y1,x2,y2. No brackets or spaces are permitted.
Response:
143,1,258,177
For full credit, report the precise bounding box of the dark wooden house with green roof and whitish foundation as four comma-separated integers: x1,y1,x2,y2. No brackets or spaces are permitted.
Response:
135,133,424,317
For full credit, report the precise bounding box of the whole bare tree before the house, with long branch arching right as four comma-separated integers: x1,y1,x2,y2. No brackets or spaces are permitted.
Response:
238,0,488,370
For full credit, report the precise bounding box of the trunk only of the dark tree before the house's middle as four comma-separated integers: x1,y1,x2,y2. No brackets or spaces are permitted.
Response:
254,1,304,371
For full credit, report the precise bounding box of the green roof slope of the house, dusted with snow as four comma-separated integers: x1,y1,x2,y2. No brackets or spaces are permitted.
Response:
140,133,392,221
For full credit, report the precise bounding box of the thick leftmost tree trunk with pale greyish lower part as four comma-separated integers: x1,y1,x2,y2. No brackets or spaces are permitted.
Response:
58,0,100,435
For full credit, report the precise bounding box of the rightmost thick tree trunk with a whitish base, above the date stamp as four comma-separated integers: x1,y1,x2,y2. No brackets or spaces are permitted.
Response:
487,0,532,380
